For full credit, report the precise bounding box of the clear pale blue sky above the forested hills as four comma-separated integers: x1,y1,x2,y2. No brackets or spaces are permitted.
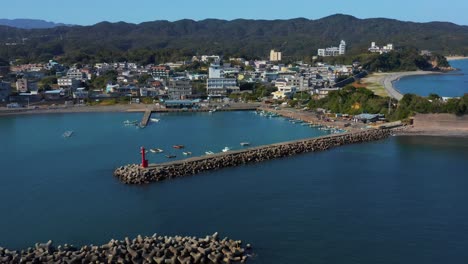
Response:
0,0,468,25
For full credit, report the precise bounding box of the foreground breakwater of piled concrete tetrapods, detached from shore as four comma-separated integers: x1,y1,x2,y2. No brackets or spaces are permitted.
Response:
0,233,251,264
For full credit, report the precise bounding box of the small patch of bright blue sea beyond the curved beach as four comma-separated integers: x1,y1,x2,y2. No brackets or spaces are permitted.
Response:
395,60,468,97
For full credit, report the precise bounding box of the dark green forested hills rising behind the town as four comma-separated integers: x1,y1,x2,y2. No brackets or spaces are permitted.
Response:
0,14,468,63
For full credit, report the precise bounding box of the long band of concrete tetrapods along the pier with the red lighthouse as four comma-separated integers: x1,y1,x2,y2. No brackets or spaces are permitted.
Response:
114,129,390,184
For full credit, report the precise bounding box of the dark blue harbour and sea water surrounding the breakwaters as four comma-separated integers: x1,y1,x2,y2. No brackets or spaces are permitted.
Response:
0,112,468,263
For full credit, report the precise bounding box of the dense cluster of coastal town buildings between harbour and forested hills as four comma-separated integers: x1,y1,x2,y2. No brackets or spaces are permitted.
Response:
0,41,372,109
